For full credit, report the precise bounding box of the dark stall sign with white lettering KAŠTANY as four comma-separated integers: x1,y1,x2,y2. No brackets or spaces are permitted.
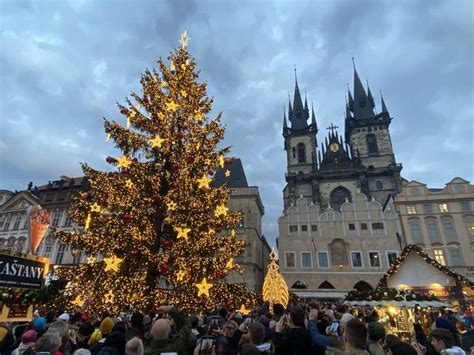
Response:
0,254,45,288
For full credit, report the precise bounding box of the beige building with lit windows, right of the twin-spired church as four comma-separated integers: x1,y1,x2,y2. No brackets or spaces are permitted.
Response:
394,177,474,280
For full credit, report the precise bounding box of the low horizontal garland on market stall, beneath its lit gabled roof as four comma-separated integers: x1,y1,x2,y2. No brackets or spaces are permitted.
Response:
345,287,439,302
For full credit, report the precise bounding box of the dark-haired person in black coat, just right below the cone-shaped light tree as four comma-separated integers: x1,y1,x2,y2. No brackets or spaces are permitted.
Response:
273,306,322,355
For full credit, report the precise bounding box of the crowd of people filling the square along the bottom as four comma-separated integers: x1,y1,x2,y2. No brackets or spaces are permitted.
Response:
0,303,474,355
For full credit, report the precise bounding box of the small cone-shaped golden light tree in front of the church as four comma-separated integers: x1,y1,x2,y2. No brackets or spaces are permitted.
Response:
263,249,289,309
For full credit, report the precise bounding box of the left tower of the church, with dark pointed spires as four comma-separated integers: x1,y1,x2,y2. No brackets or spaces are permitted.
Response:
283,70,318,208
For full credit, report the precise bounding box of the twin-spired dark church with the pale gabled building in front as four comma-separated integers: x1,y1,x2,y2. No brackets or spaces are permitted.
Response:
277,67,402,298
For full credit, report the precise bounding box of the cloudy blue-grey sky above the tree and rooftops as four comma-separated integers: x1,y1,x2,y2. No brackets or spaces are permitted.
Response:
0,0,474,248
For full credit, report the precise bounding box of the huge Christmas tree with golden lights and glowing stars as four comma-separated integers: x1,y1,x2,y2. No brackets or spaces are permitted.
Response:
52,33,256,312
